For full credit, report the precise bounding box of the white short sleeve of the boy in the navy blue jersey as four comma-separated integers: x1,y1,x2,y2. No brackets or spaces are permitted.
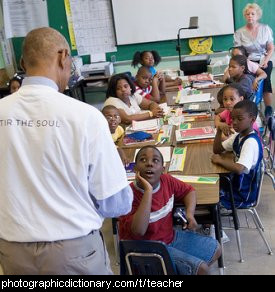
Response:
236,138,259,173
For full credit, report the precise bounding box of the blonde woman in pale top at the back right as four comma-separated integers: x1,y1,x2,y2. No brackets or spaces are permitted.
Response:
234,3,274,117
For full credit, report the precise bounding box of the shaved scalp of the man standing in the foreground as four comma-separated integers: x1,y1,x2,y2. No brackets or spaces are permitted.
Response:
22,27,70,68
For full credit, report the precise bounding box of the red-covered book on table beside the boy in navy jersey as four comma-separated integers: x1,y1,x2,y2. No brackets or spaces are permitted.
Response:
176,126,215,142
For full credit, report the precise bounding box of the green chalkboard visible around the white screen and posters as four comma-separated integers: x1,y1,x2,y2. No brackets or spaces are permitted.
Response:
13,0,275,63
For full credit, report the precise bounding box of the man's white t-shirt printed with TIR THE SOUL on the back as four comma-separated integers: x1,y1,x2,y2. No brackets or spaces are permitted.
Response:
0,80,128,242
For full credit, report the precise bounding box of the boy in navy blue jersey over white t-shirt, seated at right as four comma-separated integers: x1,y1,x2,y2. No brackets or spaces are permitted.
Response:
212,100,263,209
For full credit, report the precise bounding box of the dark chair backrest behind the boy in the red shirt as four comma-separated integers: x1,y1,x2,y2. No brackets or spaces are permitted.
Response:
120,240,177,275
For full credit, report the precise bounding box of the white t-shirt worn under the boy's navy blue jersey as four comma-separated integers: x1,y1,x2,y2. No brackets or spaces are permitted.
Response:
222,131,259,173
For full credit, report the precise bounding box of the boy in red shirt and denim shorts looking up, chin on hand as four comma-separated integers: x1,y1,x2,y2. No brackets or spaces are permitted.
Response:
119,145,221,275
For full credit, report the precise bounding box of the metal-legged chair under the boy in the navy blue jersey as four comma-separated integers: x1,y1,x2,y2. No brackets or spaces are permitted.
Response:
221,161,273,263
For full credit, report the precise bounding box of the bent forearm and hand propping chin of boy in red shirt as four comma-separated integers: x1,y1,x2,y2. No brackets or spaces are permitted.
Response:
131,171,153,236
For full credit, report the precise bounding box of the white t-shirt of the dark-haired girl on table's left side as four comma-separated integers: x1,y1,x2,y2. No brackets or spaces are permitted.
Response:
104,93,143,115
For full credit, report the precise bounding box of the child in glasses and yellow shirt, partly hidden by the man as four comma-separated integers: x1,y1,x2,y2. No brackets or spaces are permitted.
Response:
102,105,130,165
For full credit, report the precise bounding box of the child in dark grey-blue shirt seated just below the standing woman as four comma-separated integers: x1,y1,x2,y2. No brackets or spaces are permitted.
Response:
227,55,255,100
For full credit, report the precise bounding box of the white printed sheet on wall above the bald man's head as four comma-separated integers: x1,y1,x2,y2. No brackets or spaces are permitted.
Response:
3,0,49,39
